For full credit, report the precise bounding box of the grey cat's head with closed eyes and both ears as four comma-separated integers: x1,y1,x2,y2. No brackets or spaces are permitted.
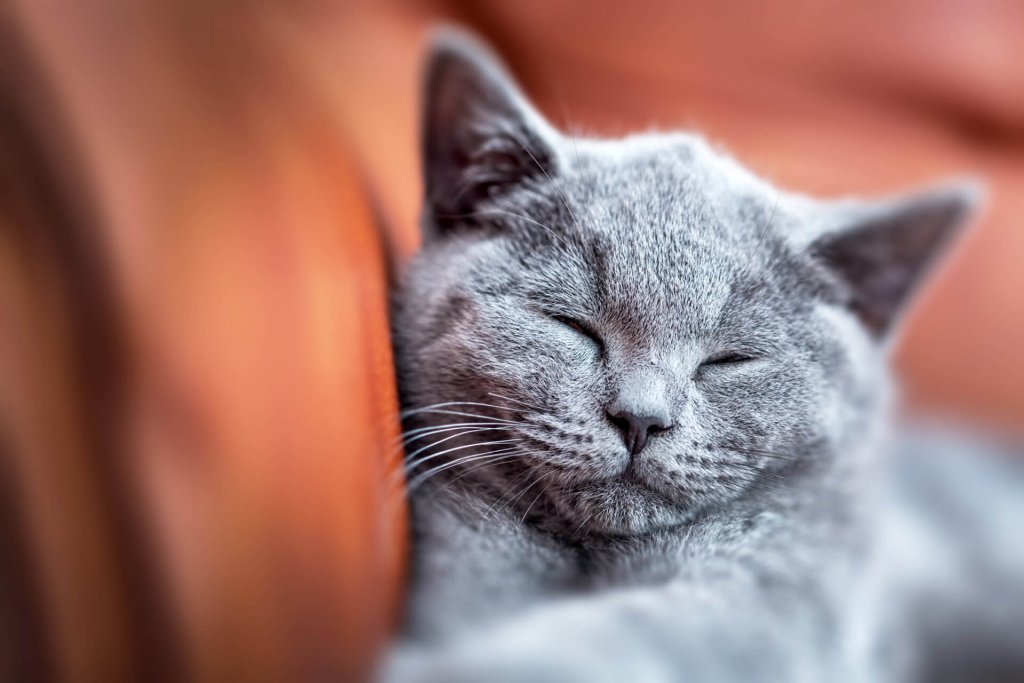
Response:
394,29,977,535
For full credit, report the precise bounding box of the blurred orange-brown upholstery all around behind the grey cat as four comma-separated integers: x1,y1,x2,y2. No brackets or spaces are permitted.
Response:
0,0,1024,681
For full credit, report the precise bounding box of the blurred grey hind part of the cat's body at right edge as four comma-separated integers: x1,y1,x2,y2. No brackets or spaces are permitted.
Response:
871,424,1024,683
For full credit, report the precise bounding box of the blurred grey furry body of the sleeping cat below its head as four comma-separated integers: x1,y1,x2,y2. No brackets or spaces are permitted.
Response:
395,436,1024,683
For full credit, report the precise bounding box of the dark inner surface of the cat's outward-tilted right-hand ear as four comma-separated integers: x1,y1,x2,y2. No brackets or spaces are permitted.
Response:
813,190,974,338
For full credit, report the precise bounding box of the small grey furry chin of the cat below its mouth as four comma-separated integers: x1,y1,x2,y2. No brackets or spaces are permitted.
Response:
558,478,693,537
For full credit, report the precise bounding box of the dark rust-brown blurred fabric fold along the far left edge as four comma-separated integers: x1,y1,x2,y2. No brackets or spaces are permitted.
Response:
0,106,140,681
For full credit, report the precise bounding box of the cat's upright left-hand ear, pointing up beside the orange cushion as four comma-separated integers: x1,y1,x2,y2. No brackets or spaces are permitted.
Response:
422,29,557,232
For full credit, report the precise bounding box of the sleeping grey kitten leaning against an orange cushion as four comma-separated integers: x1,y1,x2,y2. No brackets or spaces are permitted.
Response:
381,32,1024,681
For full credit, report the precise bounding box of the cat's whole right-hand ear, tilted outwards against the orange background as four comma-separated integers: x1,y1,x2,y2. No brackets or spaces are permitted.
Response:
809,181,984,340
